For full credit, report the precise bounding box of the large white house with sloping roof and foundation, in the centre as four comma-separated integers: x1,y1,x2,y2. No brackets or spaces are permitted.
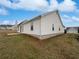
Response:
17,10,64,39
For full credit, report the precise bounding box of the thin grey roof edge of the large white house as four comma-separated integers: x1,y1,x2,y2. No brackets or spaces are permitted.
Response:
18,10,65,27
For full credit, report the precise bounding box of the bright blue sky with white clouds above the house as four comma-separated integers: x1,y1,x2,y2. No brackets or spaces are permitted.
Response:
0,0,79,26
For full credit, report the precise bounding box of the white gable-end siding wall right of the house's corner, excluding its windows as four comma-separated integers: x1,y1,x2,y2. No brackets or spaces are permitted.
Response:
41,12,64,35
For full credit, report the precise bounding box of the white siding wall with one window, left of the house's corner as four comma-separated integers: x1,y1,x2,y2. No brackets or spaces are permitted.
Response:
23,18,40,35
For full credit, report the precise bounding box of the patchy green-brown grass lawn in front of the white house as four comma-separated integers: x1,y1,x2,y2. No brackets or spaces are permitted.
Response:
0,34,79,59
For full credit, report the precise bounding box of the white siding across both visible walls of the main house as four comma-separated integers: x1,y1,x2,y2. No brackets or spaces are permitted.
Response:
17,12,64,35
